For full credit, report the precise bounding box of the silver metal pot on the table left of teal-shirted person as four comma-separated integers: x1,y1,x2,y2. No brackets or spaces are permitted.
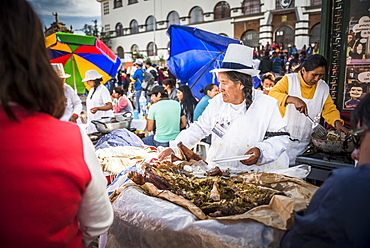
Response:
91,112,132,133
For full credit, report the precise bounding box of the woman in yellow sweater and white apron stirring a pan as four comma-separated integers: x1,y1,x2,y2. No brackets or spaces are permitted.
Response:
269,54,348,165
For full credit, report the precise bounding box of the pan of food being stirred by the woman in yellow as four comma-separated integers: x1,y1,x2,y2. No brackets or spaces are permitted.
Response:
311,130,355,153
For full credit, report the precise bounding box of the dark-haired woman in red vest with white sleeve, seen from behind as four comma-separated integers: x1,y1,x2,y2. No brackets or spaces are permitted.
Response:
0,0,114,248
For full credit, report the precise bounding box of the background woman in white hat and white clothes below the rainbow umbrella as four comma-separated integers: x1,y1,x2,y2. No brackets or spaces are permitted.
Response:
82,70,114,134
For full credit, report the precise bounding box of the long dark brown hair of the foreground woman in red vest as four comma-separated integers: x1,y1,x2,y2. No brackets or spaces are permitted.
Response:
0,0,65,120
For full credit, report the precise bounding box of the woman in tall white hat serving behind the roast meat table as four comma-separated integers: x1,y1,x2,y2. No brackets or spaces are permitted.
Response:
159,44,288,172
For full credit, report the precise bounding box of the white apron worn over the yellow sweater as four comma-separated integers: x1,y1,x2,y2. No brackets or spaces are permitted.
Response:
284,73,329,165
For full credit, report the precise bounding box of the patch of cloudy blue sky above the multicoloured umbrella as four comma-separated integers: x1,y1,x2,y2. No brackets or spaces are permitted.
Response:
27,0,101,34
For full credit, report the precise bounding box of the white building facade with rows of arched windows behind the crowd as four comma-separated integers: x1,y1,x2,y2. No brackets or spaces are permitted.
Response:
97,0,322,65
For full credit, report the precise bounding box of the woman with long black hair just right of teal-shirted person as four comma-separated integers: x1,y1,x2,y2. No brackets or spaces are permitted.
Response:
177,84,198,127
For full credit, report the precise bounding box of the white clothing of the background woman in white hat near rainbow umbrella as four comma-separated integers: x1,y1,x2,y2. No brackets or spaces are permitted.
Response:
86,84,114,134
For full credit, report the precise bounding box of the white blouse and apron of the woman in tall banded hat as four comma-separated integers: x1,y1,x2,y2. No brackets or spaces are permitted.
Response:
170,90,289,172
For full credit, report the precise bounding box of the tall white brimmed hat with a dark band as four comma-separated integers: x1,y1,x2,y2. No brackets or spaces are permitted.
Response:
210,44,260,76
